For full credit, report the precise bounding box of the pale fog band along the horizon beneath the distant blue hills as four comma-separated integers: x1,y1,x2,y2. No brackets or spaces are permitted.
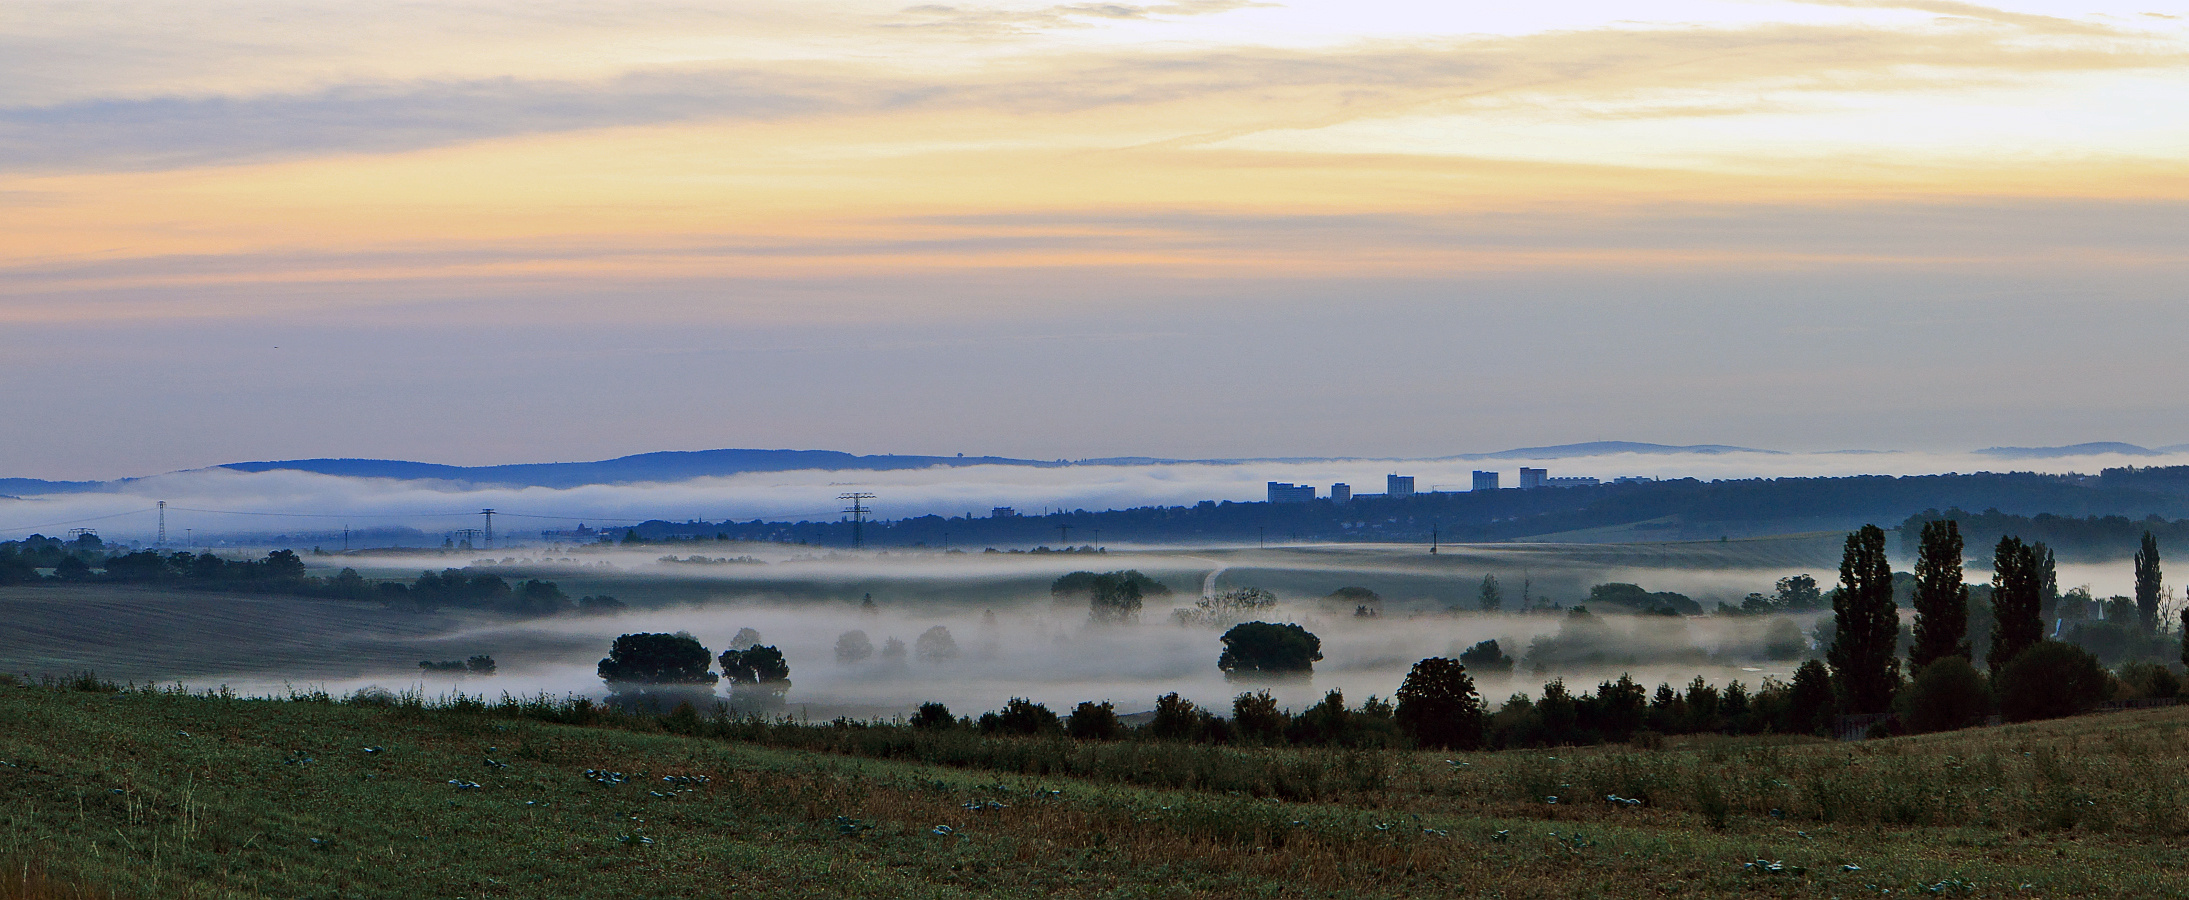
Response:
12,451,2189,541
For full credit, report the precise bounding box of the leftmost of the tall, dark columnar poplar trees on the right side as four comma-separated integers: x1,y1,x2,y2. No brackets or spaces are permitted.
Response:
1826,526,1900,714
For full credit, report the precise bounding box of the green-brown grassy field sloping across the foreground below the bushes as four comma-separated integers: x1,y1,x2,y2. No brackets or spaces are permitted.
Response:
0,685,2189,898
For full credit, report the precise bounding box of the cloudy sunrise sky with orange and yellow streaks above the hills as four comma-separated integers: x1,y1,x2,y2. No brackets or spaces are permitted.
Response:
0,0,2189,477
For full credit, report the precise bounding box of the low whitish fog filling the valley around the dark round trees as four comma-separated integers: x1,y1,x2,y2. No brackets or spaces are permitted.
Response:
190,547,1865,718
